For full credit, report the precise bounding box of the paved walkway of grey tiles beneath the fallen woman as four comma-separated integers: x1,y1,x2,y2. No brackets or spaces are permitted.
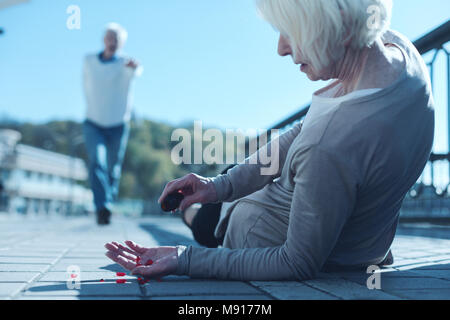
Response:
0,215,450,300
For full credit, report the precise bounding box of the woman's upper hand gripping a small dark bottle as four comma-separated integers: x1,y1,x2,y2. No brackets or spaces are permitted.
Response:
158,173,217,210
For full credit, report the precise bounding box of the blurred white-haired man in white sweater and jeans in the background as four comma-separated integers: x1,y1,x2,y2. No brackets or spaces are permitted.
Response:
83,23,142,225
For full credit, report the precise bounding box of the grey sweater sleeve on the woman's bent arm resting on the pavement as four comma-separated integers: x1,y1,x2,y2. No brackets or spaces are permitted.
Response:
176,146,356,280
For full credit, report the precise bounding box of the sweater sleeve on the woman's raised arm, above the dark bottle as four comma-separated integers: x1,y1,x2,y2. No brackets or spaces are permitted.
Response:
212,121,303,202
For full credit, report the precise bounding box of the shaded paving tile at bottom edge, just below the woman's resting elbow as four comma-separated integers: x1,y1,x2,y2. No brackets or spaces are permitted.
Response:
250,281,337,300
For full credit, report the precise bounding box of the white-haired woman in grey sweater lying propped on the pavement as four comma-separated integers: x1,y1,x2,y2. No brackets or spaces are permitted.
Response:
106,0,434,280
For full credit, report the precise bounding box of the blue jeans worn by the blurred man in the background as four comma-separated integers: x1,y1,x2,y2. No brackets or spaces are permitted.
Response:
83,120,130,211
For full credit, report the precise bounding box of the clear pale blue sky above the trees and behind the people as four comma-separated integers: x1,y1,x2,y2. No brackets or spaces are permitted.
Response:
0,0,450,151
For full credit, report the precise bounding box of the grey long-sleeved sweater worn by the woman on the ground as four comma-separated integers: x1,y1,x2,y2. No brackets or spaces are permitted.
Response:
176,30,435,280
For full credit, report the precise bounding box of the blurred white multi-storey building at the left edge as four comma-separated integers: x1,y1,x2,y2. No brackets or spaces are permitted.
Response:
0,130,92,215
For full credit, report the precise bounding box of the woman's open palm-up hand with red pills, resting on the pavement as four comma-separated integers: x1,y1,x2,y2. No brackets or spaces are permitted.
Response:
105,241,178,279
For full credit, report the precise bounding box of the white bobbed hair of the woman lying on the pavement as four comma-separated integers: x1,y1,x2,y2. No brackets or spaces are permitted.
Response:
257,0,392,70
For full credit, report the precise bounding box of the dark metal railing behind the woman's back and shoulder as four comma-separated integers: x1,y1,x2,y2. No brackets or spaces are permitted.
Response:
262,20,450,212
